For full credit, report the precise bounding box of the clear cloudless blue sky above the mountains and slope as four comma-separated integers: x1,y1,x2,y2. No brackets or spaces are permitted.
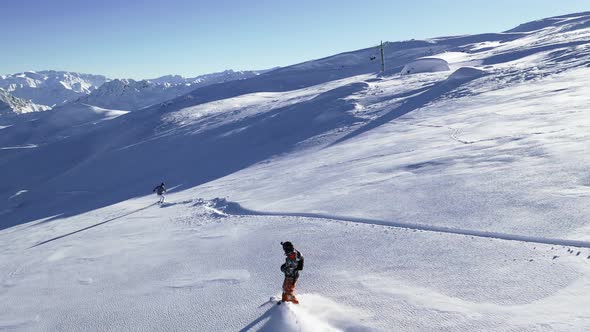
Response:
0,0,590,78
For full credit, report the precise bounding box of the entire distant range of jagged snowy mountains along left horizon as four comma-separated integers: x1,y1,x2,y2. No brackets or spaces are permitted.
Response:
0,70,264,114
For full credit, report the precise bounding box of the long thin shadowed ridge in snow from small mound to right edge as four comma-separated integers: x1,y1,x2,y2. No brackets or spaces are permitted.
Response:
225,202,590,248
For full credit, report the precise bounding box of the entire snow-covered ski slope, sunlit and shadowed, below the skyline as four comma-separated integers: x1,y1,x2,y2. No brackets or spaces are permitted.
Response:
0,13,590,331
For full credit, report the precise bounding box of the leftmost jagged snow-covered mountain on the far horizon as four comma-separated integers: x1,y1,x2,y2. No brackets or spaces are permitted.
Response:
0,70,107,107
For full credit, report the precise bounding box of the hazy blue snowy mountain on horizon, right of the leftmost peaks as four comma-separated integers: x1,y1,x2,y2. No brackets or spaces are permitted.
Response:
76,70,259,110
